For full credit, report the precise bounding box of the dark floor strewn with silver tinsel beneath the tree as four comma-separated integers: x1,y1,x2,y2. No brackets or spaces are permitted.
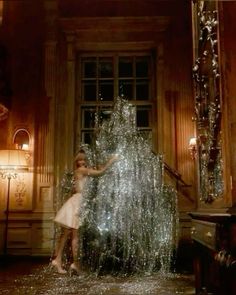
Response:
0,257,195,295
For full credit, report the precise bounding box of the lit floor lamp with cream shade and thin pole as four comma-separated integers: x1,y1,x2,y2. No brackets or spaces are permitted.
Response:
0,150,28,256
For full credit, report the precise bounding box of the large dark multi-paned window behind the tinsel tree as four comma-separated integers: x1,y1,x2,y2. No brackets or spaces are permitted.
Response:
77,53,155,144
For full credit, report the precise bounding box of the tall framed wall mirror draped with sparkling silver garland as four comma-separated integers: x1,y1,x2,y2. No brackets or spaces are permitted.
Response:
193,1,224,203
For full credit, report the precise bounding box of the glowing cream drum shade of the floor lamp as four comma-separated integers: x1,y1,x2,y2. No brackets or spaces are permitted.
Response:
0,150,28,170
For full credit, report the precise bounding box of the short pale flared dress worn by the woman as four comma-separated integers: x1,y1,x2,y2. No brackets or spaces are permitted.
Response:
54,177,86,229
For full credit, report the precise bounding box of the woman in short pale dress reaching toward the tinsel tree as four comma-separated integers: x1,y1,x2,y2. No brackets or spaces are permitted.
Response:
52,150,117,274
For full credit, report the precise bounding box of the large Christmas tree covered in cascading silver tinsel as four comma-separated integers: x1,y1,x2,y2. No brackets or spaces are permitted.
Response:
80,98,178,273
